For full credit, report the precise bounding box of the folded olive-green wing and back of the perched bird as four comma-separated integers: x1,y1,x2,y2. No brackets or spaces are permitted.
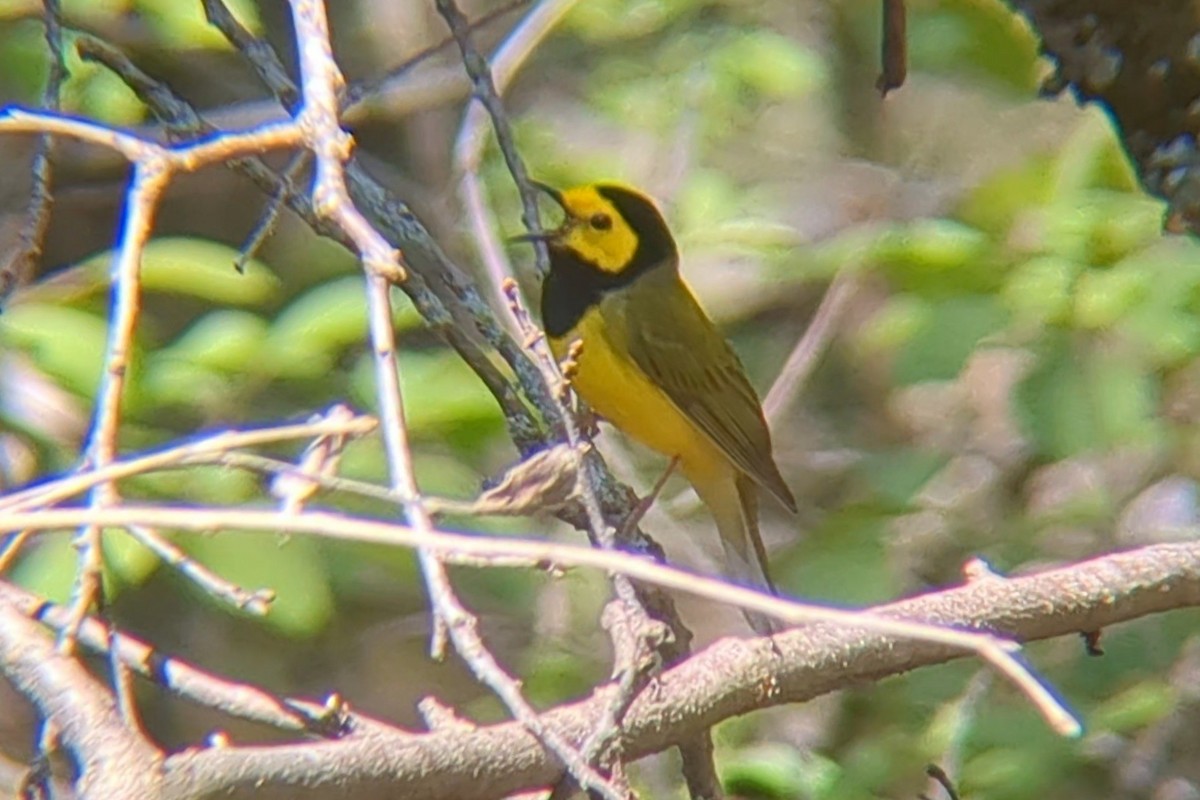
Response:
609,275,796,511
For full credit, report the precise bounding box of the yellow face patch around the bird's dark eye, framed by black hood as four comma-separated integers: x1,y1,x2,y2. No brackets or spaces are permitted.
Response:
552,186,637,272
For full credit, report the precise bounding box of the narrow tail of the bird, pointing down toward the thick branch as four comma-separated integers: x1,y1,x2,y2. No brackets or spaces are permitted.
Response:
696,474,782,636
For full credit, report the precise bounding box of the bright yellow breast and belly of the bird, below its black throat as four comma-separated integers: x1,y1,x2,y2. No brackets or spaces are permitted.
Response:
550,308,732,482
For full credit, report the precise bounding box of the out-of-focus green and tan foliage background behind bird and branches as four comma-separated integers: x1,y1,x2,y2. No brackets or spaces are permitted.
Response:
0,0,1200,800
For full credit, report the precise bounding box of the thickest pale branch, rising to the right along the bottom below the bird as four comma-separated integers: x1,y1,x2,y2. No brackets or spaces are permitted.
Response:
159,542,1200,800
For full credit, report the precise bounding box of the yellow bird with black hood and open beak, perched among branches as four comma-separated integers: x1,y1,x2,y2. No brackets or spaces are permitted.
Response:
522,184,796,633
